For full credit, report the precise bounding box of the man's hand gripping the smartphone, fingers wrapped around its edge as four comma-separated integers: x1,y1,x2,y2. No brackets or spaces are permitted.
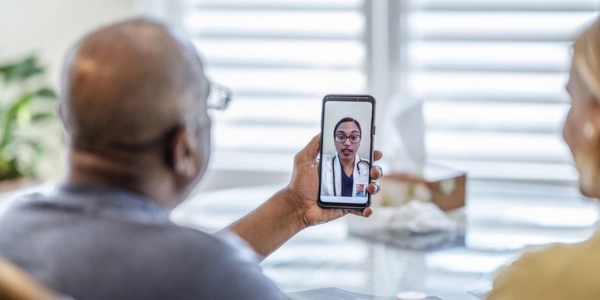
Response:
284,135,383,227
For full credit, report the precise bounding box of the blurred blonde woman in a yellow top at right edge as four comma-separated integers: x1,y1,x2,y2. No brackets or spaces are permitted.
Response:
487,20,600,300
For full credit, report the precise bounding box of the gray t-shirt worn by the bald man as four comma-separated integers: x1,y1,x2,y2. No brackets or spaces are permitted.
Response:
0,185,285,300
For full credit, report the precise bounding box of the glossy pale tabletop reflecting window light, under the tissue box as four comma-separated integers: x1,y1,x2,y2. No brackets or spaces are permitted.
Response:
172,182,599,300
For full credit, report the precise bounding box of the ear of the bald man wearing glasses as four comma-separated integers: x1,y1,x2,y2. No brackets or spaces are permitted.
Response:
169,126,201,178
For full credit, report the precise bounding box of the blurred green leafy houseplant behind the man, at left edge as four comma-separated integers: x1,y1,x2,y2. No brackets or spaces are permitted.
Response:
0,56,57,181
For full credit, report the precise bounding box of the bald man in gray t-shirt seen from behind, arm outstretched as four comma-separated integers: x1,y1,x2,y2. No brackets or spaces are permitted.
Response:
0,19,381,299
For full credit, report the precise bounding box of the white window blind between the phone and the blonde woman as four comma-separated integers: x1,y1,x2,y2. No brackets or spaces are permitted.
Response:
403,0,598,183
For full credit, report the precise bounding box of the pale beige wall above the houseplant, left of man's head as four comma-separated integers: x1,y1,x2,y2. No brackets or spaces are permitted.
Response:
0,0,135,85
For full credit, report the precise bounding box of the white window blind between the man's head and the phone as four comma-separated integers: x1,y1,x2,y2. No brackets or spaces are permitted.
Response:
182,0,367,172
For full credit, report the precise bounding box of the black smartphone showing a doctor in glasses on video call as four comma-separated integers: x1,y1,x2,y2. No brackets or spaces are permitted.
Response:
317,95,375,209
